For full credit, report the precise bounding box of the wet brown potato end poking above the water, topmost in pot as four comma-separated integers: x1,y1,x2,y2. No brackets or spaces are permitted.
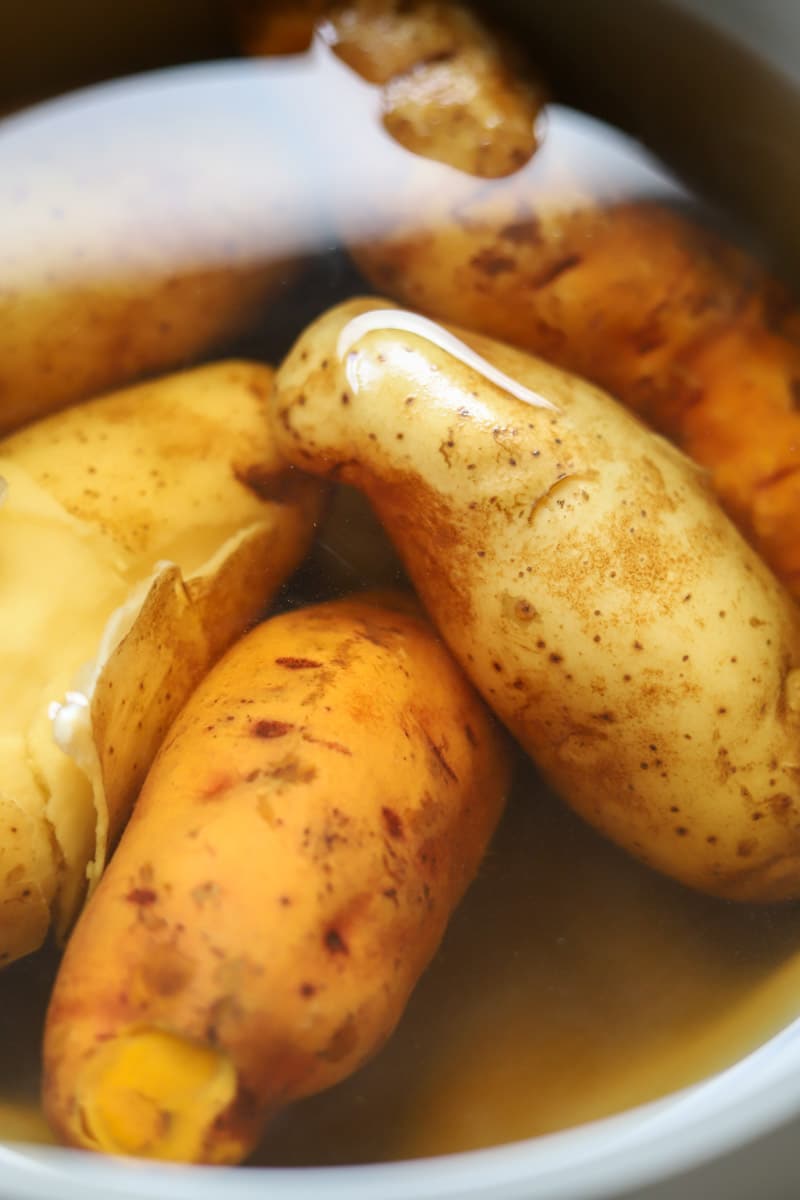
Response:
240,0,543,177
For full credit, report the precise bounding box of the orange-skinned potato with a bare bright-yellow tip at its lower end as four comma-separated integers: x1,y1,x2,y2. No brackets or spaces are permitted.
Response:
43,594,509,1163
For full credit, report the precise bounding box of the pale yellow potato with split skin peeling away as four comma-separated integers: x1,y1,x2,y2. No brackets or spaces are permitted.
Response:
0,362,319,964
